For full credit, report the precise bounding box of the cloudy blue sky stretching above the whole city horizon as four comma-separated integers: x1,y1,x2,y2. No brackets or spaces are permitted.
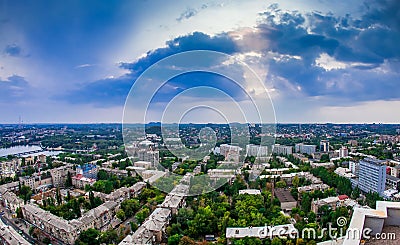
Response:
0,0,400,123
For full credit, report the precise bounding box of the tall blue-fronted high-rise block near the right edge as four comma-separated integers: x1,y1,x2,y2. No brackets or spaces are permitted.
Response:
358,158,386,195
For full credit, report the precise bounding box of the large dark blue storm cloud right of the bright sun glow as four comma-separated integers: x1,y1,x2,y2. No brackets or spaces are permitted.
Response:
257,1,400,104
